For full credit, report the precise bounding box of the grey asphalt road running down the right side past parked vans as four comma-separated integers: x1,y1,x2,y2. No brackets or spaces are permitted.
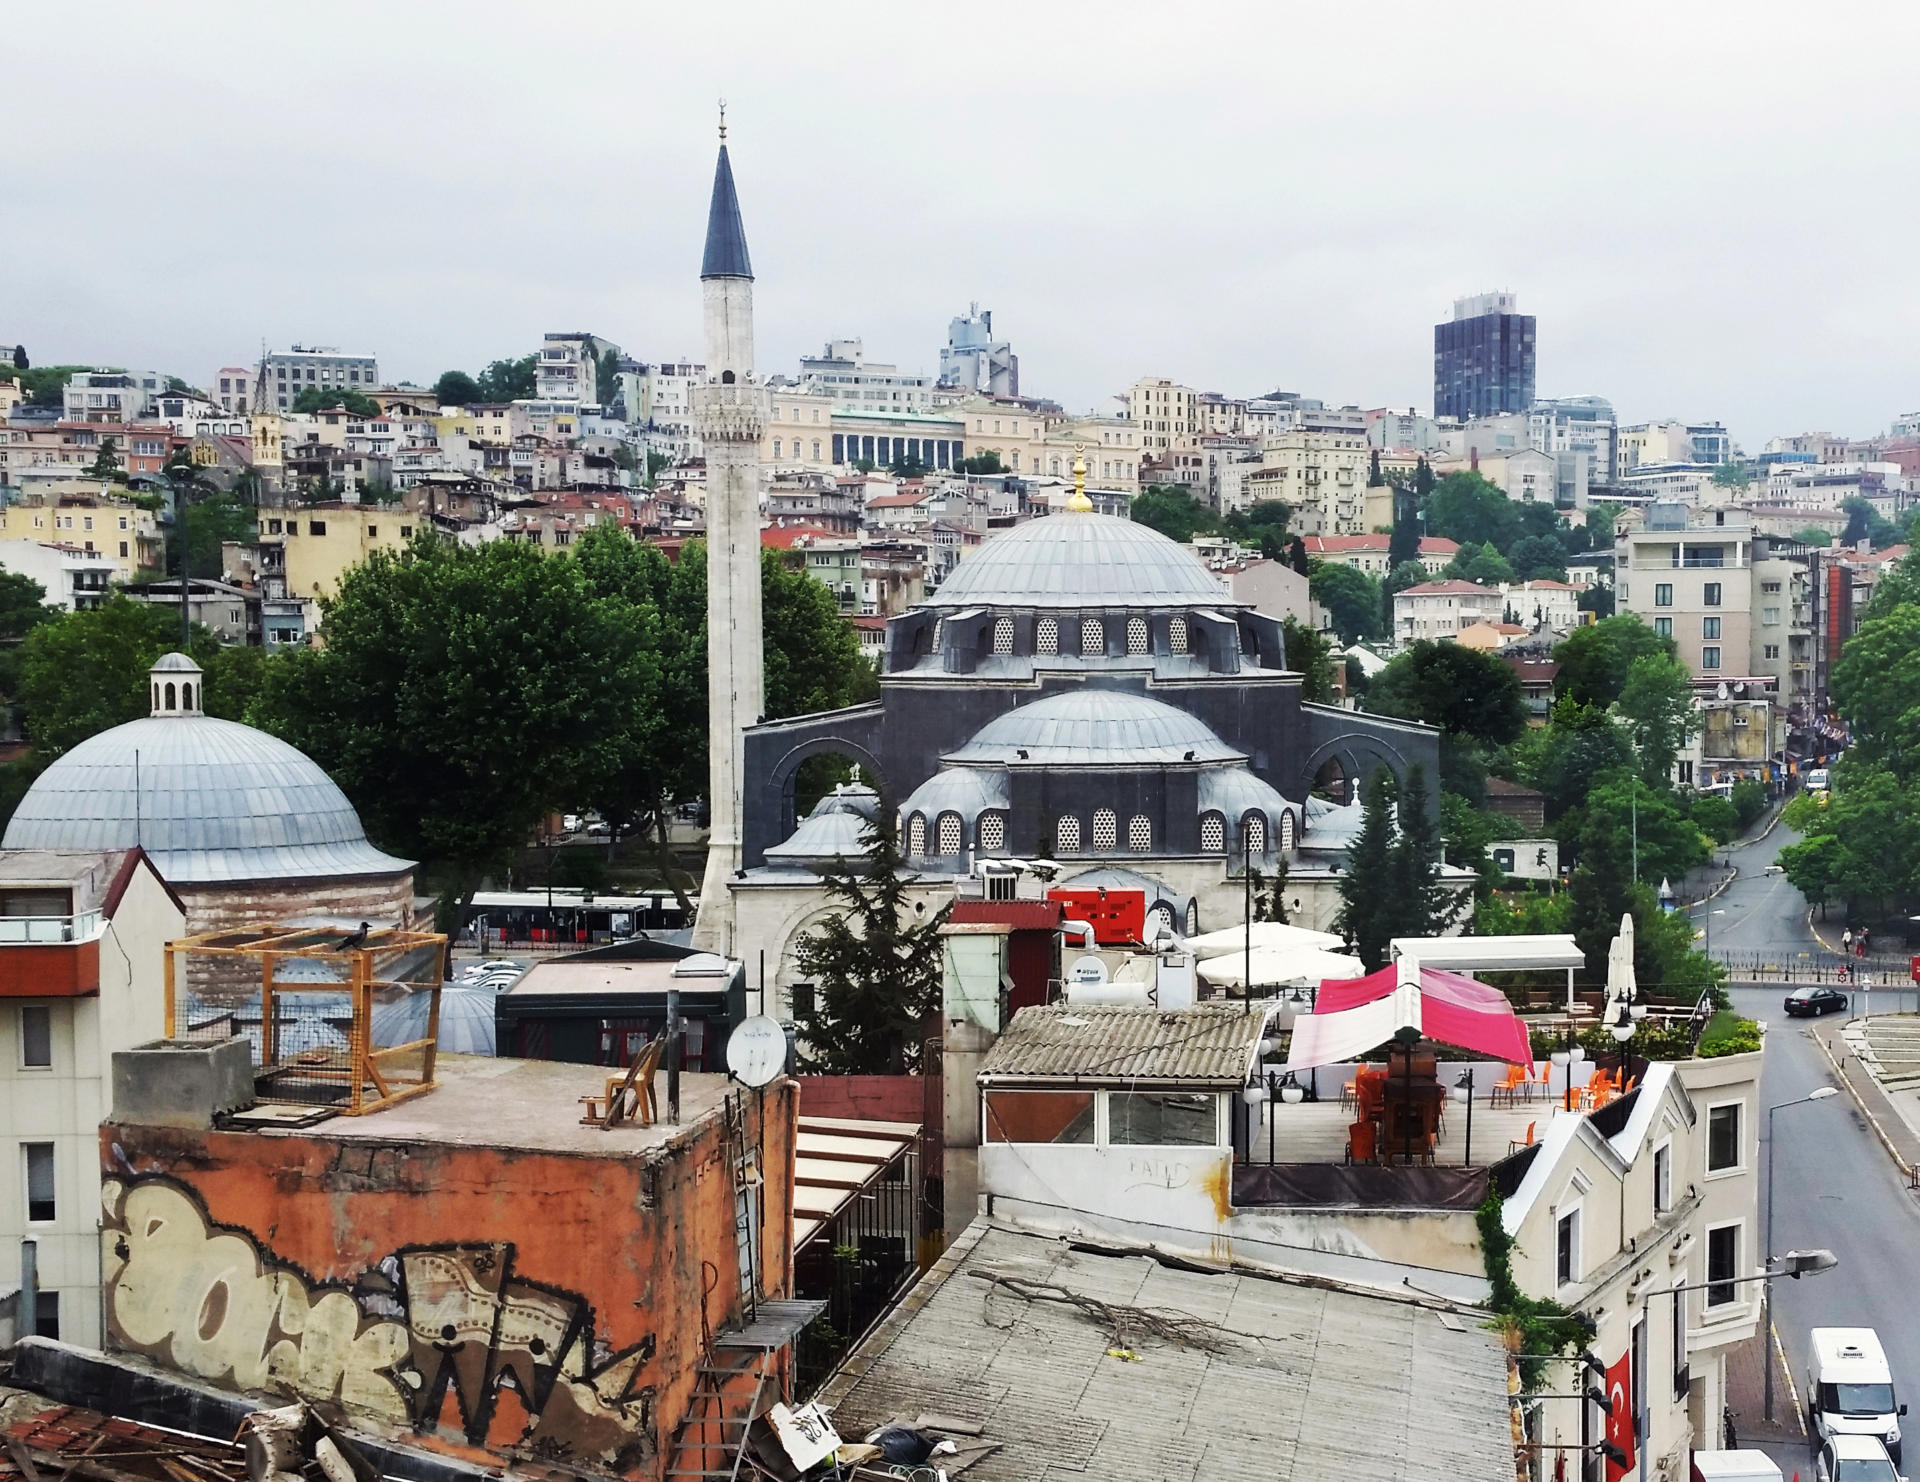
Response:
1692,827,1920,1470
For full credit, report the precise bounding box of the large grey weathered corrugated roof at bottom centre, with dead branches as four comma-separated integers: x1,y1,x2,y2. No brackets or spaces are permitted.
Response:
822,1223,1513,1482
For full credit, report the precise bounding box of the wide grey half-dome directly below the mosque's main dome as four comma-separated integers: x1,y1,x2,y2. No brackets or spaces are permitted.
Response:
948,691,1246,766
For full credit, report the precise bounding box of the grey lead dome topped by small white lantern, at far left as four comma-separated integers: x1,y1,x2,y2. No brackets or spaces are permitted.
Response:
0,653,413,885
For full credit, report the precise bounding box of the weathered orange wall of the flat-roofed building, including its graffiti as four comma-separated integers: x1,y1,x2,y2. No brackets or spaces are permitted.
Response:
102,1081,797,1478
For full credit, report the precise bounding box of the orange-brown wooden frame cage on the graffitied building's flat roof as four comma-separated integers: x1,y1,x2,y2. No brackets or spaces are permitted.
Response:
165,921,447,1115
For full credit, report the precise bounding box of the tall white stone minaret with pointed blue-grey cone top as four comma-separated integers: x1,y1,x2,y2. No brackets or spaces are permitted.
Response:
693,108,766,952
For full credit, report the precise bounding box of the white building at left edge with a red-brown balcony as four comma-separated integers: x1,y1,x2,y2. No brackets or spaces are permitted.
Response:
0,849,186,1348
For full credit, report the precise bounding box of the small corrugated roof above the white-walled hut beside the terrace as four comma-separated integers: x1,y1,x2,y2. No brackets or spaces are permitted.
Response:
979,1004,1263,1085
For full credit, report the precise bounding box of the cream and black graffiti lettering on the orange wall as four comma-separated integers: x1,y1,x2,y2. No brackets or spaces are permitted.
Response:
102,1177,659,1470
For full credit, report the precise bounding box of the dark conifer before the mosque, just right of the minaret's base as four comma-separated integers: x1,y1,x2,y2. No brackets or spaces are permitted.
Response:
793,799,952,1075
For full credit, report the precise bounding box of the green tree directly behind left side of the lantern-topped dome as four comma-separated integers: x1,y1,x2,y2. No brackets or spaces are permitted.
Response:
17,593,180,758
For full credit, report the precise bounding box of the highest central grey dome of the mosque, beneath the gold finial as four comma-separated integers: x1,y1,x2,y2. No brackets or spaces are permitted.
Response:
925,514,1229,609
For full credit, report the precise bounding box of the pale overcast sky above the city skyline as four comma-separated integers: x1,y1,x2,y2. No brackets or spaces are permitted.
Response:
0,0,1920,451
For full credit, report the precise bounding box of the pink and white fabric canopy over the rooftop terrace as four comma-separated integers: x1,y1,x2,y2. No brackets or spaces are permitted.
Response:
1286,962,1534,1069
